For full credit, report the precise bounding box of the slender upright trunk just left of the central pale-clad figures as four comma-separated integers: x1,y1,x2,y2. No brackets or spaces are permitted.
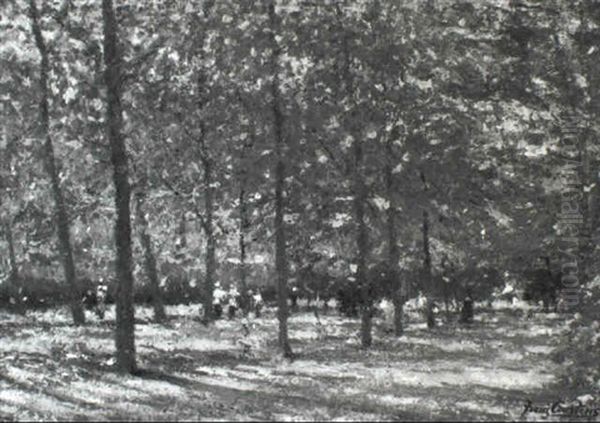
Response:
203,158,216,323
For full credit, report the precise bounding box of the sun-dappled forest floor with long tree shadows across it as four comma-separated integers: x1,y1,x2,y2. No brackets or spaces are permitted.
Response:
0,305,580,421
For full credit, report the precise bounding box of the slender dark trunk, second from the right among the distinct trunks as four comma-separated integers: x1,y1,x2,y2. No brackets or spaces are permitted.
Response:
385,141,404,336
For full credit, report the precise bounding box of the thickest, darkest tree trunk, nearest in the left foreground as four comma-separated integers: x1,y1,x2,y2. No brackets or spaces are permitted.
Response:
102,0,136,373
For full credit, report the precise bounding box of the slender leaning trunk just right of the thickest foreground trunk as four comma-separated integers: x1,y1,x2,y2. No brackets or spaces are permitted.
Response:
135,193,167,323
